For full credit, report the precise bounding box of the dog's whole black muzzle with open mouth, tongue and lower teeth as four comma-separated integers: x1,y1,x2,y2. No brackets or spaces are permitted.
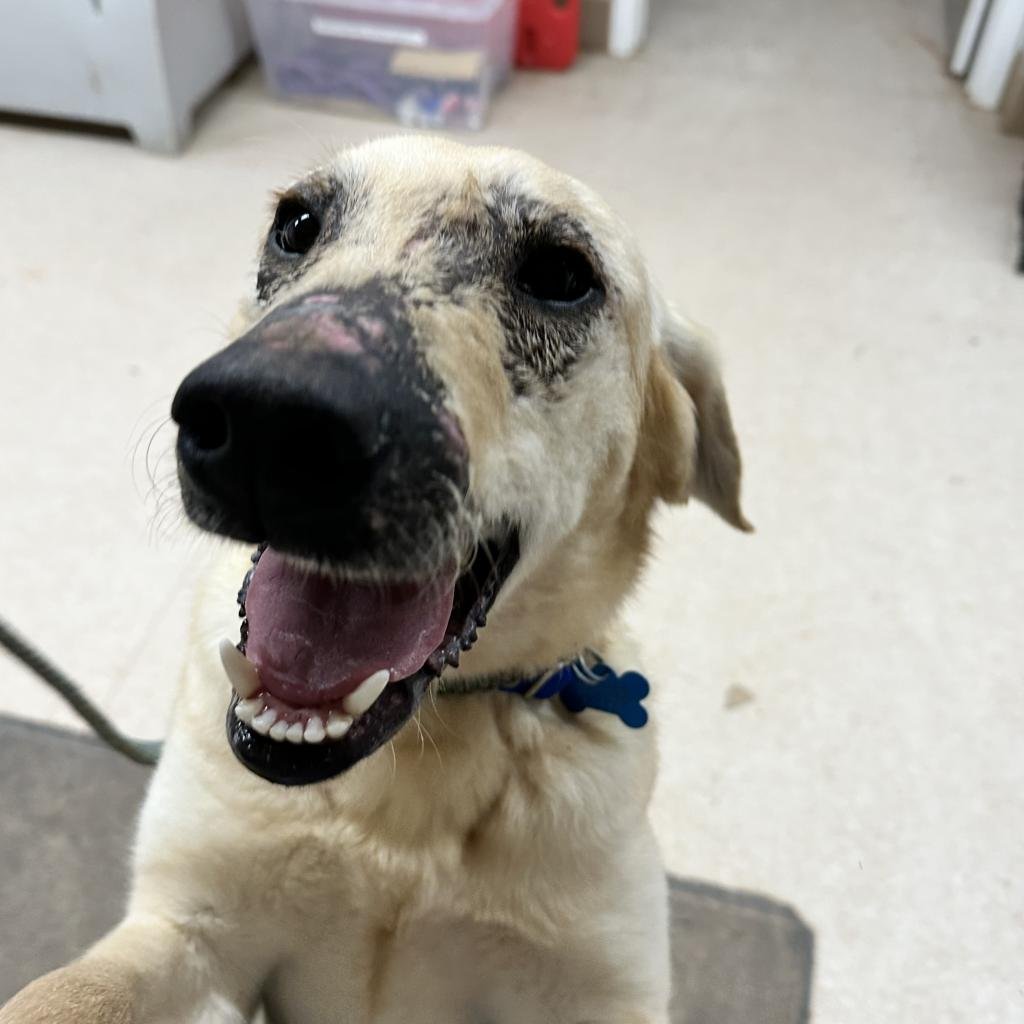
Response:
172,290,518,784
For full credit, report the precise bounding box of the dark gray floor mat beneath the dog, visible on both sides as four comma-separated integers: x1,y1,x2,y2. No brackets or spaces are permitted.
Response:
0,716,814,1024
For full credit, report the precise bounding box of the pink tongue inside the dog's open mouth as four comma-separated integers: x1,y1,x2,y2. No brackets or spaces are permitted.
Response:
246,548,455,706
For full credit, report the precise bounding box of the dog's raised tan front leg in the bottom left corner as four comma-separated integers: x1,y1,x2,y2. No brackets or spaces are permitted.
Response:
0,916,258,1024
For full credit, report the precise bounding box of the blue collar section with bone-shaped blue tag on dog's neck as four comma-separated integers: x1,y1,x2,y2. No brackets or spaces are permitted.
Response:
499,651,650,729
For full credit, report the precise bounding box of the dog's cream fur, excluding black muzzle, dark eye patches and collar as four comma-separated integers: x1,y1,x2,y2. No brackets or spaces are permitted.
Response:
0,137,745,1024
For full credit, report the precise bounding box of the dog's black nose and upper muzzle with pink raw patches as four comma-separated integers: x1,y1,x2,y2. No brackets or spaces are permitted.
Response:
171,294,468,567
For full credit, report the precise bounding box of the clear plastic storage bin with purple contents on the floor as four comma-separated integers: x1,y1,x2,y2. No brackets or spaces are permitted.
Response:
249,0,517,128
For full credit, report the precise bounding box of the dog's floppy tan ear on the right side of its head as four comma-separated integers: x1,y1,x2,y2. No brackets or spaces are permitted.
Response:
644,312,754,531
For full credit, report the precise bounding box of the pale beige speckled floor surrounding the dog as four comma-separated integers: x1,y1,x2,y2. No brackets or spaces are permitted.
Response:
0,0,1024,1024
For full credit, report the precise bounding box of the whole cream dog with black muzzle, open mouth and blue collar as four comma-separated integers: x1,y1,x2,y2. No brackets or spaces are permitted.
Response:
0,136,750,1024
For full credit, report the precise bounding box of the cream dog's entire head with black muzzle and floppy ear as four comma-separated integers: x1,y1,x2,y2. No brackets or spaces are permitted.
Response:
167,137,746,783
